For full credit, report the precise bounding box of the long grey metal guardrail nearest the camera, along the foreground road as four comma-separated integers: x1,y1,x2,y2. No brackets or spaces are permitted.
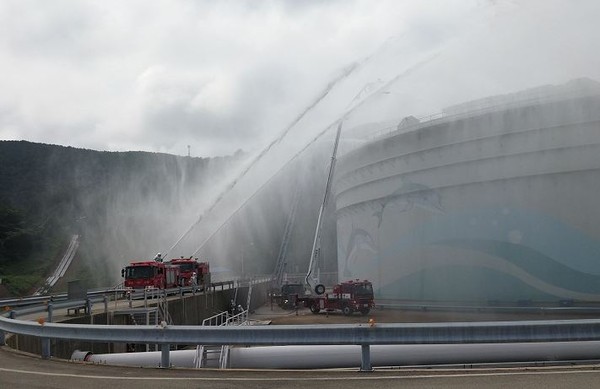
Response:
0,316,600,370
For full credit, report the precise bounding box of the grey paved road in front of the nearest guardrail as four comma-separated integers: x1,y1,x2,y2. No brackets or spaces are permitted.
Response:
0,347,600,389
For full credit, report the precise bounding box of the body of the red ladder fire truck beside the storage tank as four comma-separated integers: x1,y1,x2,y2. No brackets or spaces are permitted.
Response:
297,280,375,315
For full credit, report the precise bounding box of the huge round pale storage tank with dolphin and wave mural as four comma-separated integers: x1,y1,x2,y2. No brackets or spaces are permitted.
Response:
334,79,600,304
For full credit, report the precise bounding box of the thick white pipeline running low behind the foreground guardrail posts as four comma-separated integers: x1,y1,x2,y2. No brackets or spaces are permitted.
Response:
72,341,600,369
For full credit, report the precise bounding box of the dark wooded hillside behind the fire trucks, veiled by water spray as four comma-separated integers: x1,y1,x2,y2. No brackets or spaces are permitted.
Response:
0,141,337,297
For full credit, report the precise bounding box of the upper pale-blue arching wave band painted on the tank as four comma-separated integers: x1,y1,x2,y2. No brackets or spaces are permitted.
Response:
381,207,600,278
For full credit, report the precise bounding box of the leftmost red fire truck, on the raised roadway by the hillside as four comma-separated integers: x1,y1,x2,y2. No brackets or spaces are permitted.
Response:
121,261,180,289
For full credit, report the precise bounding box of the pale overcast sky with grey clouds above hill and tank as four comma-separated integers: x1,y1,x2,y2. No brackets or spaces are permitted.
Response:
0,0,600,156
